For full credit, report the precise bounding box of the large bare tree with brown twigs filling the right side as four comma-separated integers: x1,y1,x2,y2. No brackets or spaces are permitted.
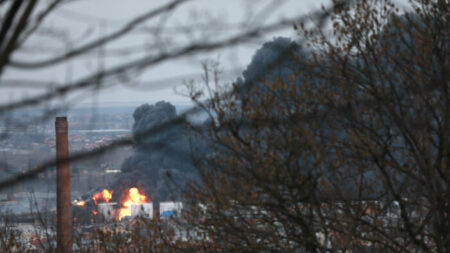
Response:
183,1,450,252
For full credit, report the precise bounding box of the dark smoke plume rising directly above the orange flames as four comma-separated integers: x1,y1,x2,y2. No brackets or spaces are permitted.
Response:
116,101,199,200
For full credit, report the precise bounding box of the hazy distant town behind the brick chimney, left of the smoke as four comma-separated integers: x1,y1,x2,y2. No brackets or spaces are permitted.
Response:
0,108,134,204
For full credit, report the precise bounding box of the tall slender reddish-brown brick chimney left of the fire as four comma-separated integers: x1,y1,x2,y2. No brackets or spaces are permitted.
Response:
55,117,72,253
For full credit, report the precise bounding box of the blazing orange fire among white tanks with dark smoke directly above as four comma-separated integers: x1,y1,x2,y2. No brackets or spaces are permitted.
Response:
74,101,201,225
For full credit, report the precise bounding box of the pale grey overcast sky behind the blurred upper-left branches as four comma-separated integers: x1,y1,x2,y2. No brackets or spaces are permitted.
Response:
0,0,329,106
